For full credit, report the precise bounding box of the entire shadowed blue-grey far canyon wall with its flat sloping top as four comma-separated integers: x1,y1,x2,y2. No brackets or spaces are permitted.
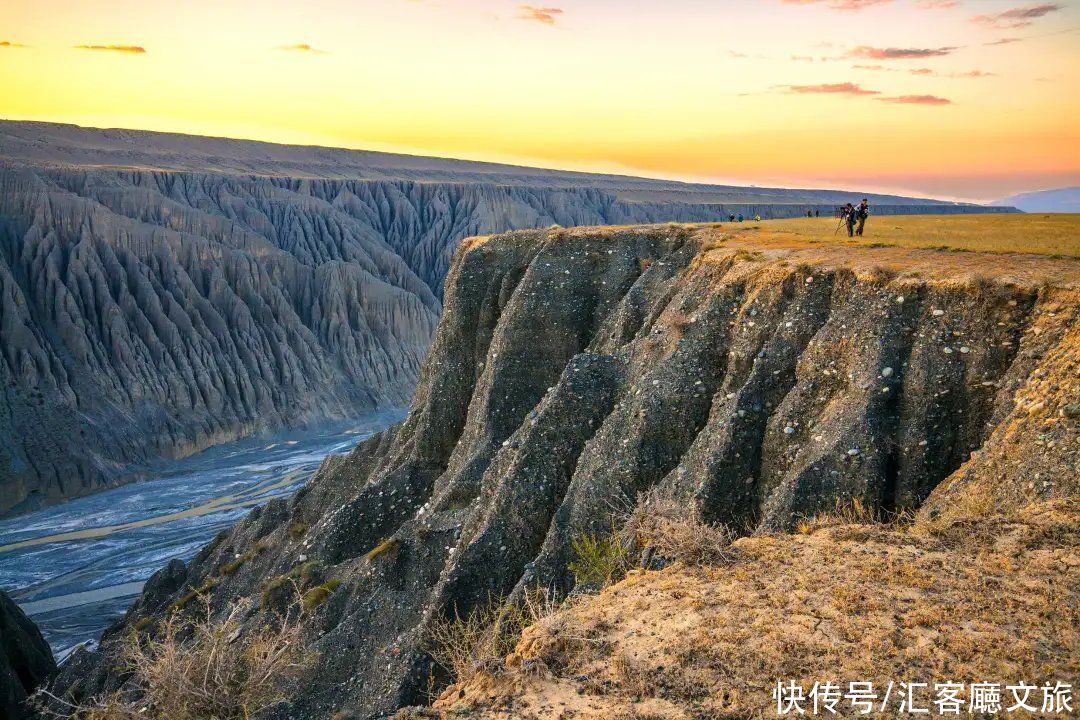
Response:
0,122,1010,514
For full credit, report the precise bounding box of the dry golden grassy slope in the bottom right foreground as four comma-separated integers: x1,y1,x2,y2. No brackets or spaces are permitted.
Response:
425,500,1080,720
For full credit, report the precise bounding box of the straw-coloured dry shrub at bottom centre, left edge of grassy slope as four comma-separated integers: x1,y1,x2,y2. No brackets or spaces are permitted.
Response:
424,587,559,683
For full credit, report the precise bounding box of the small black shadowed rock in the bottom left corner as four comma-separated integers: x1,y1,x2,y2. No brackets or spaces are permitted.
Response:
0,592,56,720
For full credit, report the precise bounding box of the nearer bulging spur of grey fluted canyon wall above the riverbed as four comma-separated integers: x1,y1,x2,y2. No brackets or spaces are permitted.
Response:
0,169,441,513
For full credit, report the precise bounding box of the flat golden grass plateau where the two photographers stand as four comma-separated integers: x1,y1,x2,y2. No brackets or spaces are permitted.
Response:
751,214,1080,258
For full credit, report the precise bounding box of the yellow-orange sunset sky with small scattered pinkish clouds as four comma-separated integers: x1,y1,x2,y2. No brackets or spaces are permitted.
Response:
0,0,1080,201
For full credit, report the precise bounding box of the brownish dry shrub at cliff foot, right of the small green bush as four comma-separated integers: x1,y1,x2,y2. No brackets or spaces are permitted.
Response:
622,489,735,566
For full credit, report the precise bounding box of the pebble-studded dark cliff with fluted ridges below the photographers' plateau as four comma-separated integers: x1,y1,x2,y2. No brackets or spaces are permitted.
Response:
44,226,1080,719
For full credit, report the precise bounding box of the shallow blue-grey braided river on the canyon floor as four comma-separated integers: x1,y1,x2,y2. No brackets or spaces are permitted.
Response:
0,411,404,658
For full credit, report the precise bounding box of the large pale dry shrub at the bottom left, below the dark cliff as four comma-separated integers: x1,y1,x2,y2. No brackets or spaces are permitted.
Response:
39,603,314,720
